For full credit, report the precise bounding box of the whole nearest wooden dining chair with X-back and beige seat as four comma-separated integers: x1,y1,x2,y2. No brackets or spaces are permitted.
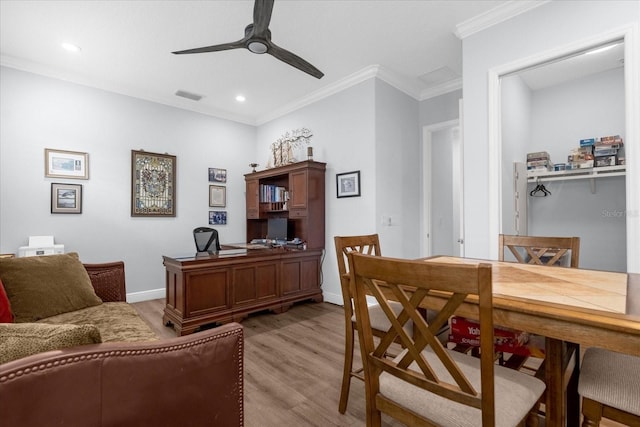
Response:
349,253,545,427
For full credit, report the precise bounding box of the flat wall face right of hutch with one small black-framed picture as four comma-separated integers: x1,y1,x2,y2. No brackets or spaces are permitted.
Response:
256,79,378,304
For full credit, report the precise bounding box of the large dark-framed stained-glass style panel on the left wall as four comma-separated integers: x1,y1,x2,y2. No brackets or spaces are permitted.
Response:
131,150,176,217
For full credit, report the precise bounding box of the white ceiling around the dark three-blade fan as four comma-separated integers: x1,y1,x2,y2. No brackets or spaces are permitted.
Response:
0,0,560,124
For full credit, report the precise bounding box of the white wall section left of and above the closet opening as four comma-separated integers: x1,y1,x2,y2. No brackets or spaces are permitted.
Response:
462,1,640,268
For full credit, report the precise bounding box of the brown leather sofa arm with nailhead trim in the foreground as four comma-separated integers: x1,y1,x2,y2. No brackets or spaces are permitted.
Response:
0,323,244,427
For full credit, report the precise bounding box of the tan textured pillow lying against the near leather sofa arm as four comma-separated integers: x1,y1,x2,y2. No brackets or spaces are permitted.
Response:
0,323,101,364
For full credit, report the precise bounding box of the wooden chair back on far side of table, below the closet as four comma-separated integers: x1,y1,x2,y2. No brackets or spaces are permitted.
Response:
498,234,580,268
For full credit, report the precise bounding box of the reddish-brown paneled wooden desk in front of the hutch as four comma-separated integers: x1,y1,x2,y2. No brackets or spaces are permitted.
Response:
162,248,323,336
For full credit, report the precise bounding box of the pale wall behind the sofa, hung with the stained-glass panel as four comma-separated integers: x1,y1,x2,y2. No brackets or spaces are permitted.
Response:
0,67,256,298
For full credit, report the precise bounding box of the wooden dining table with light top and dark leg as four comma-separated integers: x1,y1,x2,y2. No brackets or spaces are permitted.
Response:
412,256,640,426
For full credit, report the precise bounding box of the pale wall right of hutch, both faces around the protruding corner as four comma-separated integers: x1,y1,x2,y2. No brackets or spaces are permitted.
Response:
257,79,421,304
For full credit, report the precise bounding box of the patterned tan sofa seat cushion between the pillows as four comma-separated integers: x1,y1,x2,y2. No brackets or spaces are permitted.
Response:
38,302,157,342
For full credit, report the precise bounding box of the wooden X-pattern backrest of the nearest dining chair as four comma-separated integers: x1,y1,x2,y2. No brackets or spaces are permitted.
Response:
348,251,495,425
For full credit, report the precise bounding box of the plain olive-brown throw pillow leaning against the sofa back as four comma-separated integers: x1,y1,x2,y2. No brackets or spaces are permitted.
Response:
0,252,102,322
